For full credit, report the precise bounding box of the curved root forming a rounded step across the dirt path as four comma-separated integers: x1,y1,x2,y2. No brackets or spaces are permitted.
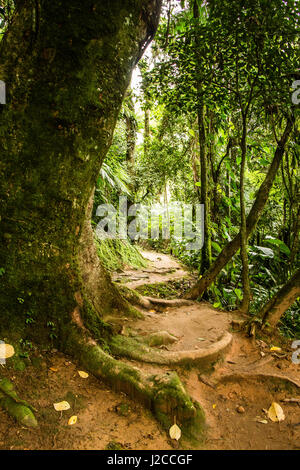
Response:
111,332,232,368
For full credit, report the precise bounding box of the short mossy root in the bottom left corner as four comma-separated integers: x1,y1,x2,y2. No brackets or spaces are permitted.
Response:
0,379,38,427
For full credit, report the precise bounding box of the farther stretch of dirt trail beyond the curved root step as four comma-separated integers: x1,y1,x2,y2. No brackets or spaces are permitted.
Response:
113,250,230,358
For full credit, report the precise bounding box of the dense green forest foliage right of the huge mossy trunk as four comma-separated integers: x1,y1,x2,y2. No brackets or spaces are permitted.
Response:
132,0,300,334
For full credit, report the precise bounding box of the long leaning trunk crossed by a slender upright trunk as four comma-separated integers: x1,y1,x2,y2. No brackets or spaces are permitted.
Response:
186,118,294,299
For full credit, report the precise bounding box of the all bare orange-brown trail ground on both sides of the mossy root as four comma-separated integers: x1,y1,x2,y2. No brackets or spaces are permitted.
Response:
0,251,300,450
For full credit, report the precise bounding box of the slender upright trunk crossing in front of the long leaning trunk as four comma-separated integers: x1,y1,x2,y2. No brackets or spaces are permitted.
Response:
240,117,250,313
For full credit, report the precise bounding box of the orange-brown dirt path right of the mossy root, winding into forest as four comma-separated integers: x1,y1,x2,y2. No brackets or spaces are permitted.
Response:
114,248,300,450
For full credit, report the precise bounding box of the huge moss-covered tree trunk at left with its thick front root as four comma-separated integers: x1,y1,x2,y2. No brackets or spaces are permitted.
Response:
0,0,203,440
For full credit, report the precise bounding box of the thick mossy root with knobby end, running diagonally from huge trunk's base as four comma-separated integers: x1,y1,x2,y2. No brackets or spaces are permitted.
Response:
63,328,205,443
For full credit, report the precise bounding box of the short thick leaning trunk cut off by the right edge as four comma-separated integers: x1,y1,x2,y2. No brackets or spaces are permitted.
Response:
258,269,300,329
